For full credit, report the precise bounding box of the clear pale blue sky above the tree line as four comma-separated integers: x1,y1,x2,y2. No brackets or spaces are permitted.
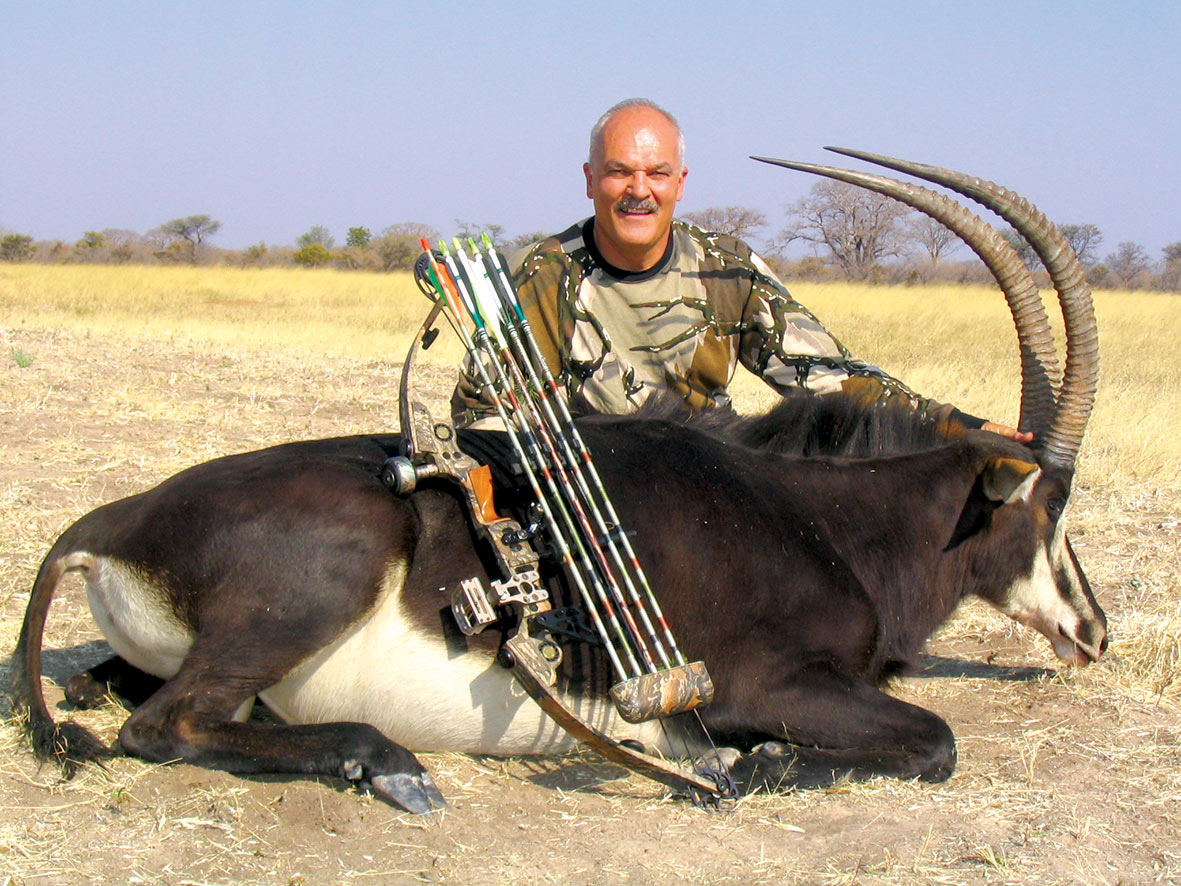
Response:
0,0,1181,258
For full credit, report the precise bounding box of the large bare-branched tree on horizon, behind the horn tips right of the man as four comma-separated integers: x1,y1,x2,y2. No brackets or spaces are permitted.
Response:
779,181,911,280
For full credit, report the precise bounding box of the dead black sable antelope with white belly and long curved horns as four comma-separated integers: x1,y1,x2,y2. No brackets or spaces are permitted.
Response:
11,152,1107,812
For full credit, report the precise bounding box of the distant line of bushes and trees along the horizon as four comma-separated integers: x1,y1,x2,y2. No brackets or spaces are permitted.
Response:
0,196,1181,291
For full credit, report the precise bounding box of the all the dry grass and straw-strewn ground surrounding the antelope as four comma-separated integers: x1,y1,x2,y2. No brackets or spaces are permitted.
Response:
0,266,1181,886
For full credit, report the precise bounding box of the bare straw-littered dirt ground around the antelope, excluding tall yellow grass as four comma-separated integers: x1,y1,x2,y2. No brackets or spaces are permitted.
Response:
0,328,1181,886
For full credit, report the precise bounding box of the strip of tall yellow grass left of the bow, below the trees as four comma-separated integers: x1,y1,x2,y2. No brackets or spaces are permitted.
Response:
0,265,470,365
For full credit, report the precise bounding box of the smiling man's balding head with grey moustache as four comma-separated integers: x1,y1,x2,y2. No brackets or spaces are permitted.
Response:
582,98,689,271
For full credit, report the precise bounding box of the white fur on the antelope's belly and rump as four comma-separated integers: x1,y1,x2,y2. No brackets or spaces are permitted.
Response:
80,553,684,755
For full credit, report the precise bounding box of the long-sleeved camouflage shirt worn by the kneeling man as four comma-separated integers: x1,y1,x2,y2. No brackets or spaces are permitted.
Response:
452,219,980,426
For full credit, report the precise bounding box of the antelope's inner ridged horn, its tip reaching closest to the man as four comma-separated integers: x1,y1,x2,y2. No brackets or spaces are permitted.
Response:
752,157,1058,441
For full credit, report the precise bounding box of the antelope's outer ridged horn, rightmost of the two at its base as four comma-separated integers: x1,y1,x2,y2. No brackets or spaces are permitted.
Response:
828,148,1098,467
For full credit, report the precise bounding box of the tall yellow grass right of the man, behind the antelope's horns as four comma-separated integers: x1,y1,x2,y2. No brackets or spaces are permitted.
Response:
737,282,1181,490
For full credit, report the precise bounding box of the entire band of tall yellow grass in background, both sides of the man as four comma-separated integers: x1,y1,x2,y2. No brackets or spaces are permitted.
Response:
0,265,1181,489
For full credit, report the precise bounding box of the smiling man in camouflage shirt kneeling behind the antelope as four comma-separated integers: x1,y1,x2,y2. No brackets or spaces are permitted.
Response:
452,99,1032,442
